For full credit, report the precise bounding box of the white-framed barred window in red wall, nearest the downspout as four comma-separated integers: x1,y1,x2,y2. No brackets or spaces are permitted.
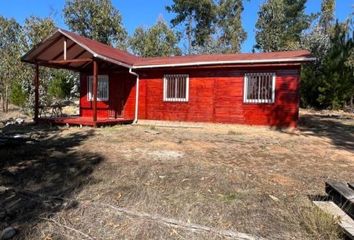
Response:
163,74,189,102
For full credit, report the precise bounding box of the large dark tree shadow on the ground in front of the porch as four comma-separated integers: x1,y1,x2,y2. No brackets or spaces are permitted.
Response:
0,125,103,235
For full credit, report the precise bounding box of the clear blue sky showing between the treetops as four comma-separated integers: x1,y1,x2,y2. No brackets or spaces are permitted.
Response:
0,0,354,52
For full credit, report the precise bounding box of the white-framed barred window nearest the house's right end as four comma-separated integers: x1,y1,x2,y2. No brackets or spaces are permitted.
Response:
243,73,275,103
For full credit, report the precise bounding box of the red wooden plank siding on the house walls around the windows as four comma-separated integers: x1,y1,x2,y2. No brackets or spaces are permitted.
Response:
80,66,300,127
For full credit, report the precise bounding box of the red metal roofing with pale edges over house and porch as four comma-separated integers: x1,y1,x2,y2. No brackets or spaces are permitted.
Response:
22,29,314,69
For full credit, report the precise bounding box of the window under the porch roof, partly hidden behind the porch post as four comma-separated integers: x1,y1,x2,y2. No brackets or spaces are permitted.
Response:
87,75,109,101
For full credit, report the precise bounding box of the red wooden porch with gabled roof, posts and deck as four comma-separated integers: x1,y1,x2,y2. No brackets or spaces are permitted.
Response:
22,29,138,127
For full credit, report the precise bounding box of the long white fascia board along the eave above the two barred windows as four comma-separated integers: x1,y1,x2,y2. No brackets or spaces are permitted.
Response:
132,57,316,69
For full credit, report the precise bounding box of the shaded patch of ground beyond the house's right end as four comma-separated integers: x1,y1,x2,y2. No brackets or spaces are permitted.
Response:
298,115,354,151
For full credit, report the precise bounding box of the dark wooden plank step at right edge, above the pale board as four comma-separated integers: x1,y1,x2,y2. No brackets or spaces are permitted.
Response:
326,180,354,218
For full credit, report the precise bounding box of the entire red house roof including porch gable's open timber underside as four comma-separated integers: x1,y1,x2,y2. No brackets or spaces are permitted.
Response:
22,29,315,70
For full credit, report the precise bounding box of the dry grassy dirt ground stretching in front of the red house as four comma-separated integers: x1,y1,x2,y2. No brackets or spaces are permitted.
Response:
0,107,354,240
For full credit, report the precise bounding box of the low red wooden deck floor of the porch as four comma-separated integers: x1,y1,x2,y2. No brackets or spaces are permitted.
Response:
38,116,133,126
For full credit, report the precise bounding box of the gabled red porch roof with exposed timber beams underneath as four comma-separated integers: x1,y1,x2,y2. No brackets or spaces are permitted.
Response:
21,29,140,70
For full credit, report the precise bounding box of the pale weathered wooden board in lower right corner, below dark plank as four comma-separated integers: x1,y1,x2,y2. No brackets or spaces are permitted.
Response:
313,201,354,240
